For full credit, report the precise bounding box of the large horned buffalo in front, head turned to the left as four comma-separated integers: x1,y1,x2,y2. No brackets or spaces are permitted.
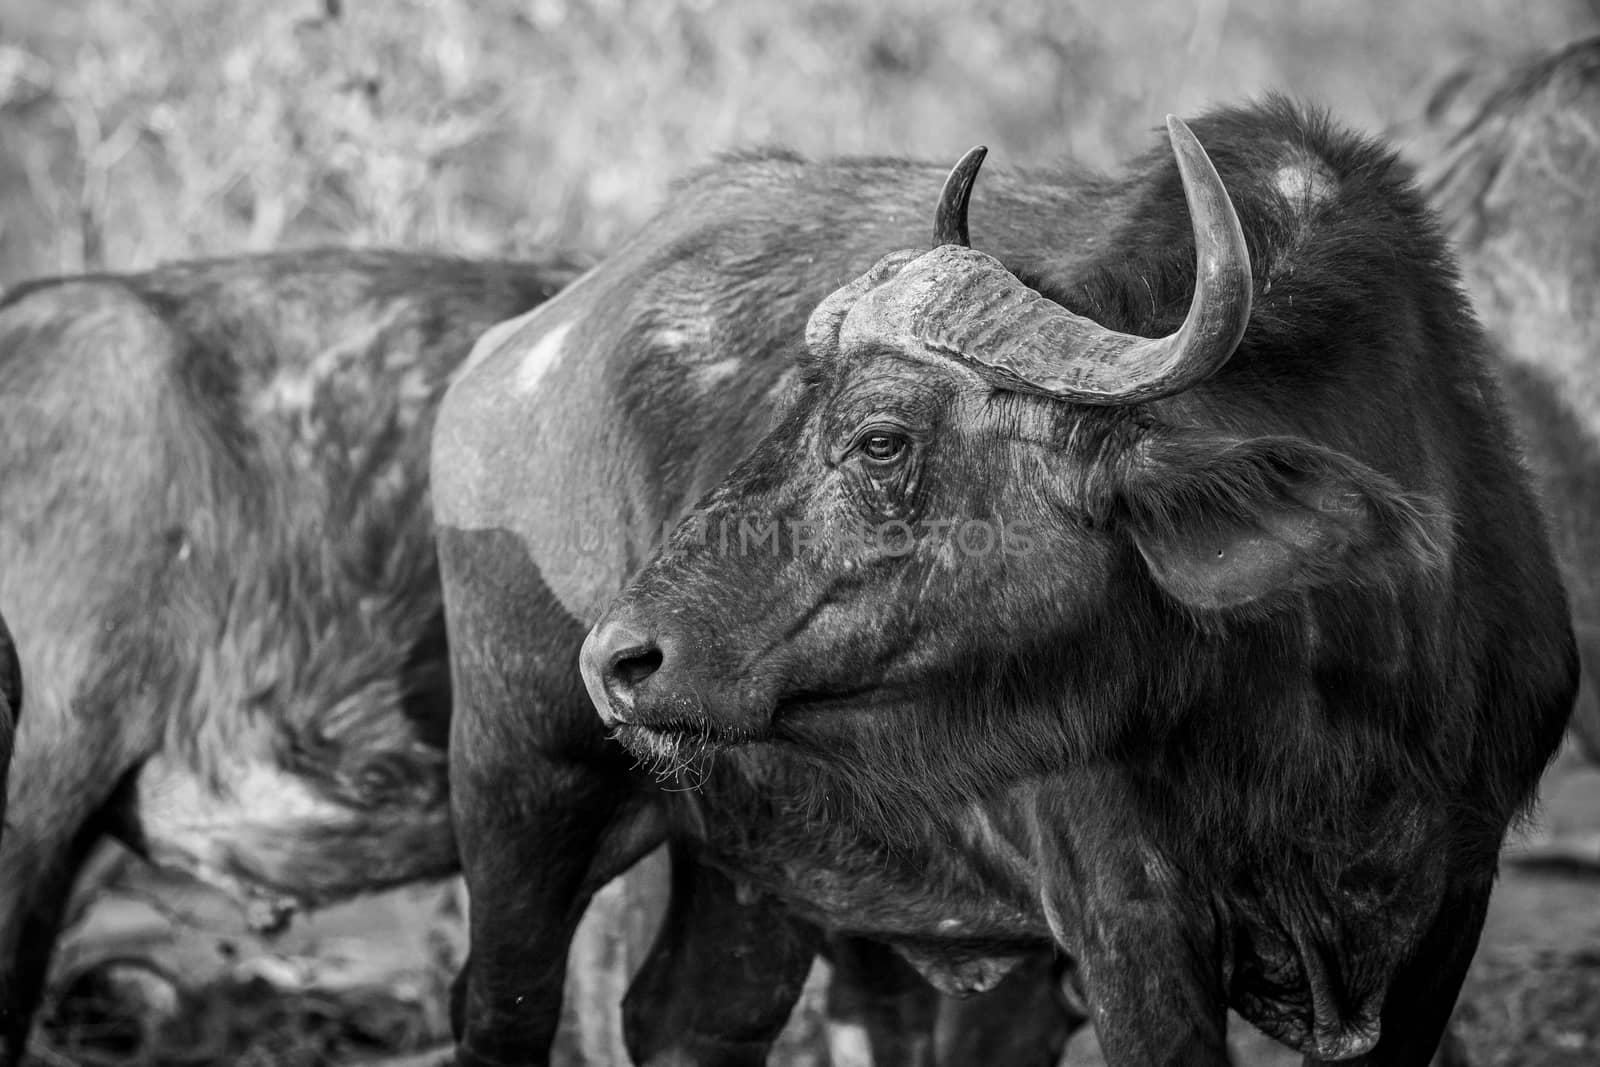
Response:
432,101,1578,1065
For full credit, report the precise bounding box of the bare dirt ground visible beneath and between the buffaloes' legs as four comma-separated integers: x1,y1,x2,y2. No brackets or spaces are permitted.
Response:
34,739,1600,1067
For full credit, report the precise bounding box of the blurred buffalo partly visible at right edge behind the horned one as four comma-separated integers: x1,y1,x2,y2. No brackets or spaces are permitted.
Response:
1424,38,1600,760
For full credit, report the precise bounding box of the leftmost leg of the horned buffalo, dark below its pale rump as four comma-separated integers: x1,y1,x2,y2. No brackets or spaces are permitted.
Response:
438,526,661,1067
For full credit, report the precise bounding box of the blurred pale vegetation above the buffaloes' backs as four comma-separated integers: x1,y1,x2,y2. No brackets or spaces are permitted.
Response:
0,0,1600,285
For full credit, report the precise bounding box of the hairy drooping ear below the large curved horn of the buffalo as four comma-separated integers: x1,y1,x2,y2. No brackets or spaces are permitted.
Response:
1122,434,1450,609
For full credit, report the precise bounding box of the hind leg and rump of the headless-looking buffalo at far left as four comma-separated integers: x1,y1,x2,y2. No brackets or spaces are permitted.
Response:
0,286,176,1062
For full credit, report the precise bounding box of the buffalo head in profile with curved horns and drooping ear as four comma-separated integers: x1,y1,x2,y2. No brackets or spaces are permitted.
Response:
581,118,1438,783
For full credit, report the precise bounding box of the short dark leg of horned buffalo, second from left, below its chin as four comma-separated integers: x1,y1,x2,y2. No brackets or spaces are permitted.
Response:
622,846,819,1067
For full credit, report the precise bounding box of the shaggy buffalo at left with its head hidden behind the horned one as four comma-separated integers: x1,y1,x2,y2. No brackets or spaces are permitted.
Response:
0,251,579,1062
